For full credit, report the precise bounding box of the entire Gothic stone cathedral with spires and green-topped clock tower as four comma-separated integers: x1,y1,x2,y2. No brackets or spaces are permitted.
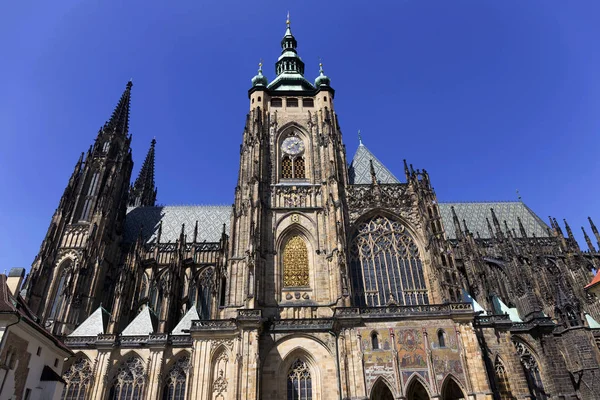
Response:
22,17,600,400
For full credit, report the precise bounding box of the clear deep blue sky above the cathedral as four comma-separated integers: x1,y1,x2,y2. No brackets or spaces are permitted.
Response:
0,0,600,270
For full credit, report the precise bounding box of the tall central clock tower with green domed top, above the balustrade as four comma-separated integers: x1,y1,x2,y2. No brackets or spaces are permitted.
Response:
223,17,348,318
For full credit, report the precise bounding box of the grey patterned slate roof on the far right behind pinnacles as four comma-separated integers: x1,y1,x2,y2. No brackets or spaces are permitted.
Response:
439,201,548,239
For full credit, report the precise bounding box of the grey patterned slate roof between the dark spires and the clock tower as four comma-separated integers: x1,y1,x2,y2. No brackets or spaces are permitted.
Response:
125,206,231,243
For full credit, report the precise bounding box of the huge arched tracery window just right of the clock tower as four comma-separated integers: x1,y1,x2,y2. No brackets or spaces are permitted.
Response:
350,216,429,307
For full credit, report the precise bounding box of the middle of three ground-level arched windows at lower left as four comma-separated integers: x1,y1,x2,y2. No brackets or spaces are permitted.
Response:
109,356,146,400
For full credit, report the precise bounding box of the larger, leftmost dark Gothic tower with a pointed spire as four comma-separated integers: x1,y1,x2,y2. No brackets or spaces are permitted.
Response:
25,82,133,335
